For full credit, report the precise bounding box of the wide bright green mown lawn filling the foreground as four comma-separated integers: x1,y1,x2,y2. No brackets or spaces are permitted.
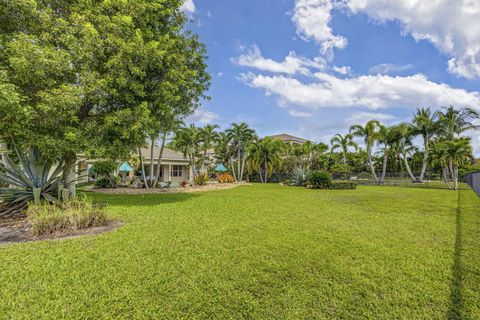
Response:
0,185,480,319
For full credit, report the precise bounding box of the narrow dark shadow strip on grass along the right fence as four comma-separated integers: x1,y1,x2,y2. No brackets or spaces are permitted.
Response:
447,191,464,319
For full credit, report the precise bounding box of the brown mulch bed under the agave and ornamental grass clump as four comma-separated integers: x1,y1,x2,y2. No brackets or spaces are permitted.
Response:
0,217,123,246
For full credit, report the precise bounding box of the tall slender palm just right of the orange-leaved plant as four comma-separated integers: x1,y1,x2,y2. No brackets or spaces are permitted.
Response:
227,122,256,181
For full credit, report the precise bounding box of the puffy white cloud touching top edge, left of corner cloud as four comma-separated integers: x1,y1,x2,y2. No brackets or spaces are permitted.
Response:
292,0,348,58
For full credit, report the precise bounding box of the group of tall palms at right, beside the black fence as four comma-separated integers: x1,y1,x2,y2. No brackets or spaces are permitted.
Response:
344,107,479,189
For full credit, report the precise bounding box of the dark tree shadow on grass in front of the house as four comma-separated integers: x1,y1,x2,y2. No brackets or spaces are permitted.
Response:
85,192,202,207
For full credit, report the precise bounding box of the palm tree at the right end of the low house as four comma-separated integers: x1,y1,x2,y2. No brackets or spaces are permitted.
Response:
172,124,200,174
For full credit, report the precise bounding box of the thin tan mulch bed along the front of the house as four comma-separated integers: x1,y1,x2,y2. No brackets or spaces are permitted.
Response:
90,182,251,194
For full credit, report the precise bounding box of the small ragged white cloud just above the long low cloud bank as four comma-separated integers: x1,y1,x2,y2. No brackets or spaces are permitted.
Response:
232,45,325,75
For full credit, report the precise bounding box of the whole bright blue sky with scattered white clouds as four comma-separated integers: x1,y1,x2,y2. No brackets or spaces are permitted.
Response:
181,0,480,151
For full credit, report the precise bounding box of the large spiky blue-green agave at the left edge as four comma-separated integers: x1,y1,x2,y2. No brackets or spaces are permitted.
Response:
0,146,64,218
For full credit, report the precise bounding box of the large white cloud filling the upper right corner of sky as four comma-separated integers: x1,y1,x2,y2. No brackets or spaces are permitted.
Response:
346,0,480,78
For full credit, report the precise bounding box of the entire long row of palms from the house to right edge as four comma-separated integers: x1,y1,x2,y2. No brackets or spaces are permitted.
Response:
170,107,479,189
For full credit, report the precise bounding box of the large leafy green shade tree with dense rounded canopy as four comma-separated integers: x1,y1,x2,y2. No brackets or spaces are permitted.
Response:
0,0,209,193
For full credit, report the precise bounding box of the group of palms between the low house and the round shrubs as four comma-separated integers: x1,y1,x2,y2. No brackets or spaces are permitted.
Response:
170,122,328,183
